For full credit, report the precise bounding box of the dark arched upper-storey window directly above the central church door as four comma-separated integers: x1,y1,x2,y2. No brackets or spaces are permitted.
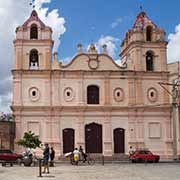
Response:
87,86,99,104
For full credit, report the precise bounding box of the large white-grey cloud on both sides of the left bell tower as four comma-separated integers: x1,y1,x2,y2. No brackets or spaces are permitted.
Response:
0,0,65,111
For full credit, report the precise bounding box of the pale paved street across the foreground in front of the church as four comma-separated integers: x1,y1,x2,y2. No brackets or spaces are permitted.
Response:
0,163,180,180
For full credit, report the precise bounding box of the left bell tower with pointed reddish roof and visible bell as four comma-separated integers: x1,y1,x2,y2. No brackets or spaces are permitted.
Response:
13,10,53,70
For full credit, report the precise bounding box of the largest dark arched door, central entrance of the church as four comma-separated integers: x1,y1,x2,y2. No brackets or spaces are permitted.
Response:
85,123,102,153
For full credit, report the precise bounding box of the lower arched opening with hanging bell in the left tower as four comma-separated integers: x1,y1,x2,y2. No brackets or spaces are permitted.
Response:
29,49,39,69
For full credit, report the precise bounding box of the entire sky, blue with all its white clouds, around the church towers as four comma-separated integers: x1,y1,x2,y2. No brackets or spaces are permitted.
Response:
0,0,180,112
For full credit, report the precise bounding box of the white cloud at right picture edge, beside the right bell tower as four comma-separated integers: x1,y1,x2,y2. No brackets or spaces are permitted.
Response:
167,24,180,62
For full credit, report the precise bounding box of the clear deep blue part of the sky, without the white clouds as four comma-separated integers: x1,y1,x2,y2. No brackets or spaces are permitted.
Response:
41,0,180,59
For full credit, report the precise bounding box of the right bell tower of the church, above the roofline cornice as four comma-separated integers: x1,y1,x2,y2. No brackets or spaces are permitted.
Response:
120,12,167,72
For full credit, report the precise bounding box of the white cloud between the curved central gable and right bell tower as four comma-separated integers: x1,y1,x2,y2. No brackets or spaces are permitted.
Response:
95,36,120,58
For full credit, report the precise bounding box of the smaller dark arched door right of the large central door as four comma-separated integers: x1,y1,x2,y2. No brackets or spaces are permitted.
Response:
113,128,125,153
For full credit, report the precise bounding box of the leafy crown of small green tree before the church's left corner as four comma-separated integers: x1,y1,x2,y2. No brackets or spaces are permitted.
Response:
16,131,41,149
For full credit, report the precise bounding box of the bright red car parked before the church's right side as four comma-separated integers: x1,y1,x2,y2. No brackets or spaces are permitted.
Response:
129,150,160,163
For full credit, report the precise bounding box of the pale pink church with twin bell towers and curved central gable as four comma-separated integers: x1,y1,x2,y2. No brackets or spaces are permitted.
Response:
12,10,180,158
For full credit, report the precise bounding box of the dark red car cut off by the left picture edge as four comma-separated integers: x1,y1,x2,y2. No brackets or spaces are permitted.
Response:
0,149,23,162
